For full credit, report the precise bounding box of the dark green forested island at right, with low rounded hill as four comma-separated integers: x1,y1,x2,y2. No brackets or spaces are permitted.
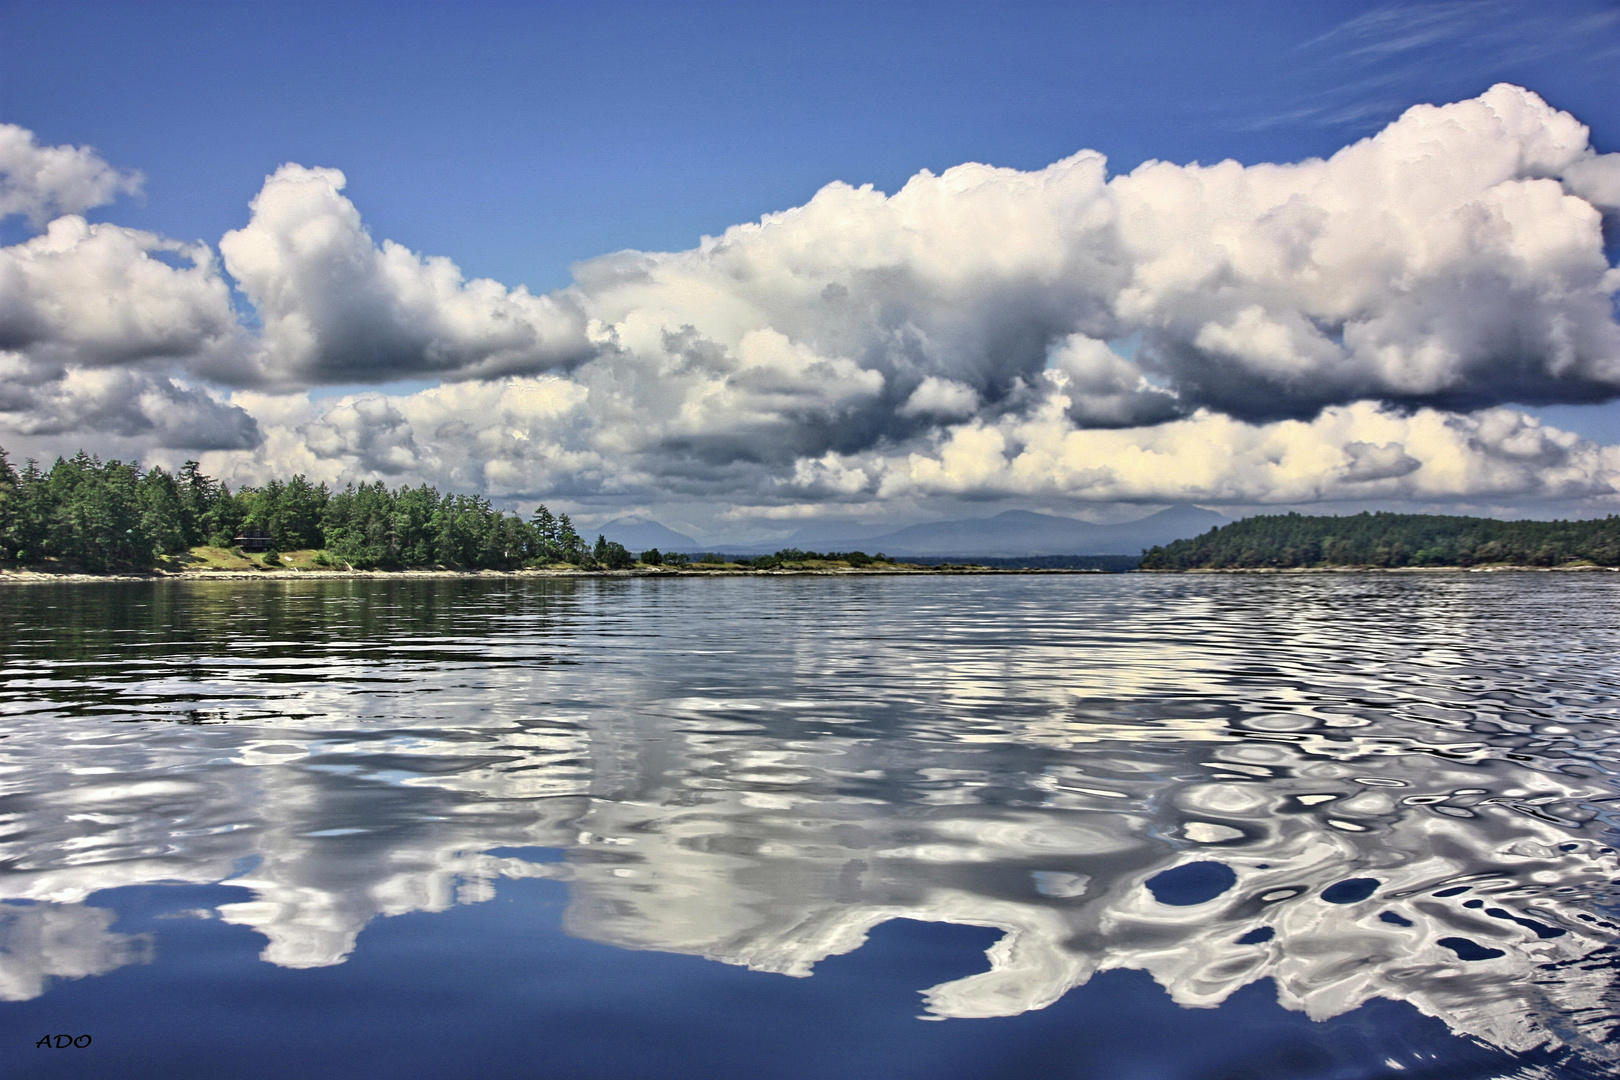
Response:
1140,512,1620,570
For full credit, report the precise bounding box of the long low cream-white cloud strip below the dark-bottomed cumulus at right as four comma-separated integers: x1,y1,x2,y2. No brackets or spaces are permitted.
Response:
848,395,1620,504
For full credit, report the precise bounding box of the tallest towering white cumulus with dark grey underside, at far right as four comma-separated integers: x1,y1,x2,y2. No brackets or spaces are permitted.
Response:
1110,84,1620,418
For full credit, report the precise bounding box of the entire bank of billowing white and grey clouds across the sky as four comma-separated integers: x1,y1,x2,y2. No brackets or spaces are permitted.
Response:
0,84,1620,513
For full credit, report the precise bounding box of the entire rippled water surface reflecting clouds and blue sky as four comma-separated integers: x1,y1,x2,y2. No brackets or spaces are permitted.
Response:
0,573,1620,1080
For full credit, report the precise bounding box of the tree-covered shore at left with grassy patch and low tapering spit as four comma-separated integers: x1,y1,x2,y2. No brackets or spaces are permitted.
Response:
0,450,893,573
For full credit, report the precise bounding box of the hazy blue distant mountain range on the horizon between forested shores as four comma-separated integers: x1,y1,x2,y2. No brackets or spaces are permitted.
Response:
605,505,1230,559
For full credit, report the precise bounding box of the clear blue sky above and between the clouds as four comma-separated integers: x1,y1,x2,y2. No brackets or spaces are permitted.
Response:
0,0,1620,534
